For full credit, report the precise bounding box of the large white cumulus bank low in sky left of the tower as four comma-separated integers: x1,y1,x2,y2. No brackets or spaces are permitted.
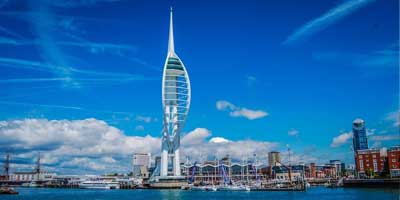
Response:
0,118,161,172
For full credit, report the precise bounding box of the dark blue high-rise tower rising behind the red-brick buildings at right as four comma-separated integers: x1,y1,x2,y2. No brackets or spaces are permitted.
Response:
353,119,368,151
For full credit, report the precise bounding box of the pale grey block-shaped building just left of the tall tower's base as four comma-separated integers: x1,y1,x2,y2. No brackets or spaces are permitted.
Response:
132,153,151,178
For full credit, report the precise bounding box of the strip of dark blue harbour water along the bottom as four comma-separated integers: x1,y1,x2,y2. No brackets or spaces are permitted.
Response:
0,187,400,200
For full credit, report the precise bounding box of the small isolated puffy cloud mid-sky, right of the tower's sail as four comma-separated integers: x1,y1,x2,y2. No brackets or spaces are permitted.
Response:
216,100,268,120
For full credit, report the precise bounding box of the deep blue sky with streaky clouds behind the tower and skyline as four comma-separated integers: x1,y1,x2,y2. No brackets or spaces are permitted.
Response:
0,0,400,172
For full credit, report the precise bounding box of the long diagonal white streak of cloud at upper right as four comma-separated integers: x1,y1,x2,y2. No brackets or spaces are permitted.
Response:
283,0,374,44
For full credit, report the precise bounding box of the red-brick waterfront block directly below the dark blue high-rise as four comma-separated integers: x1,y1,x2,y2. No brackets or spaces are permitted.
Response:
356,149,386,176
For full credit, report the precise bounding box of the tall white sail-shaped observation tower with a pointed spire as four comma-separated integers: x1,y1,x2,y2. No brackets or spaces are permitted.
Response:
160,8,191,177
